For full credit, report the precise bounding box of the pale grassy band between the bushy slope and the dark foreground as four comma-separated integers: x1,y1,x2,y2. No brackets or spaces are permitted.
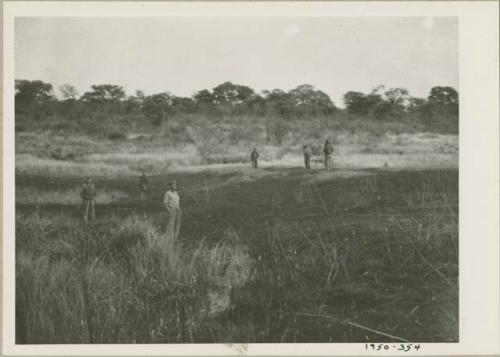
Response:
16,127,458,177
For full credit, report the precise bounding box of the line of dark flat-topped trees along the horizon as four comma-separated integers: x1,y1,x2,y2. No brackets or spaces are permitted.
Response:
15,80,459,131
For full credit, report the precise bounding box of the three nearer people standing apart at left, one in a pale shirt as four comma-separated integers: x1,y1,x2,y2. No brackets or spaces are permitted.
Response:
80,171,182,241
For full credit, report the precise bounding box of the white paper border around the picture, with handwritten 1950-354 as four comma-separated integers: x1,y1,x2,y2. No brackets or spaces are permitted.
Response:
2,1,500,356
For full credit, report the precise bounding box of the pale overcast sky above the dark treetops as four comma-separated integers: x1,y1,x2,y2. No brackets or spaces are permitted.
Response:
15,18,458,106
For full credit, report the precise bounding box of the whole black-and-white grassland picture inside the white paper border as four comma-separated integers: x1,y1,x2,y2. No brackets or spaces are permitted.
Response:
4,1,498,354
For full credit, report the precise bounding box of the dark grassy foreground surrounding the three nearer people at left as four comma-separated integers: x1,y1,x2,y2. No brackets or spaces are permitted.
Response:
16,161,459,343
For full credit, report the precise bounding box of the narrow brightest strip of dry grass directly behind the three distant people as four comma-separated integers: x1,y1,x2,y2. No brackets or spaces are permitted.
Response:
16,133,458,177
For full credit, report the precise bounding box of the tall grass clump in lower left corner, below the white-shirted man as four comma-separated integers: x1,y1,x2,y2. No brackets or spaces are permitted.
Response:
16,213,253,343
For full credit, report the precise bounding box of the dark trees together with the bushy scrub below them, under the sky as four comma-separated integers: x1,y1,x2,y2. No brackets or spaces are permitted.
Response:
15,80,458,139
